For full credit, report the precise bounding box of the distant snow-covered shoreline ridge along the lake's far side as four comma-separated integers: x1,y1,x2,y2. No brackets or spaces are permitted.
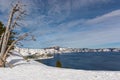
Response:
14,46,120,55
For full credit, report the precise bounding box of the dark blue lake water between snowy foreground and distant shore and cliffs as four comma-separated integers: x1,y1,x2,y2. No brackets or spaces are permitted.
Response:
37,52,120,71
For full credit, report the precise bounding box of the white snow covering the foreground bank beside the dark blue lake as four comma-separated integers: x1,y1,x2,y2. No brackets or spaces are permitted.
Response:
0,52,120,80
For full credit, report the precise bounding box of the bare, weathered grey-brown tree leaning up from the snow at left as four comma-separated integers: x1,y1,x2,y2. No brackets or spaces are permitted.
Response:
0,2,28,67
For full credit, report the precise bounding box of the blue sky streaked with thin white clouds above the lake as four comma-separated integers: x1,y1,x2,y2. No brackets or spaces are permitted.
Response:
0,0,120,48
